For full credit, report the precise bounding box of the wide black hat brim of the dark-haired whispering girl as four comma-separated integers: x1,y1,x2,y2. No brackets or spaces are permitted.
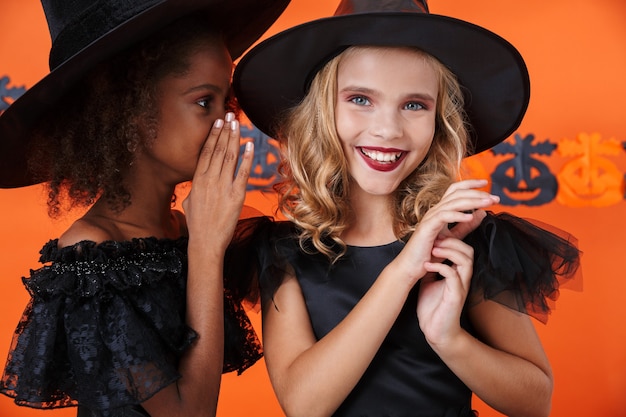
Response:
0,0,290,188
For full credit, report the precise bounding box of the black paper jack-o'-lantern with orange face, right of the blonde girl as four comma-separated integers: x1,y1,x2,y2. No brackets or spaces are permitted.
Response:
491,134,558,206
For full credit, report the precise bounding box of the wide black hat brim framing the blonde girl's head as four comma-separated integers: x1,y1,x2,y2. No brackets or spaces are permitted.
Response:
233,12,530,158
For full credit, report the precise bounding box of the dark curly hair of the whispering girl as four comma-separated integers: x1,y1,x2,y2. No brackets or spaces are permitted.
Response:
29,16,234,217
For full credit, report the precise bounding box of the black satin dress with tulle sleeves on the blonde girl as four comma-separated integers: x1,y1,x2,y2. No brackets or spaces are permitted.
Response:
255,214,579,417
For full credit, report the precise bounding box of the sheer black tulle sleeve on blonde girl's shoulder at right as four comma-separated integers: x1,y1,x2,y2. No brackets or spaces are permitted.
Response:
465,212,582,323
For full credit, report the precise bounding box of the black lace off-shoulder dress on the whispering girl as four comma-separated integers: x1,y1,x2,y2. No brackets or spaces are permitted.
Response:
0,232,262,417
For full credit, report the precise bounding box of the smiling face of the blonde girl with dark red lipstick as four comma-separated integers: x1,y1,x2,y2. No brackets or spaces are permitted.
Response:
336,47,439,195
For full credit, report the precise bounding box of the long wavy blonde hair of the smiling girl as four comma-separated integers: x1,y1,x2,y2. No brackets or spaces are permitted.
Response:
274,46,469,261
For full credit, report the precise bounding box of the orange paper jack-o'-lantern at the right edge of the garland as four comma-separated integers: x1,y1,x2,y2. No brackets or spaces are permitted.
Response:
557,133,624,207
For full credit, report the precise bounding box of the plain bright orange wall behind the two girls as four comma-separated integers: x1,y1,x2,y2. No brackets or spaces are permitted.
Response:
0,0,626,417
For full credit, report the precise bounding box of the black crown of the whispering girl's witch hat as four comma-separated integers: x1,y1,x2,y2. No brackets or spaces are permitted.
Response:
41,0,162,70
